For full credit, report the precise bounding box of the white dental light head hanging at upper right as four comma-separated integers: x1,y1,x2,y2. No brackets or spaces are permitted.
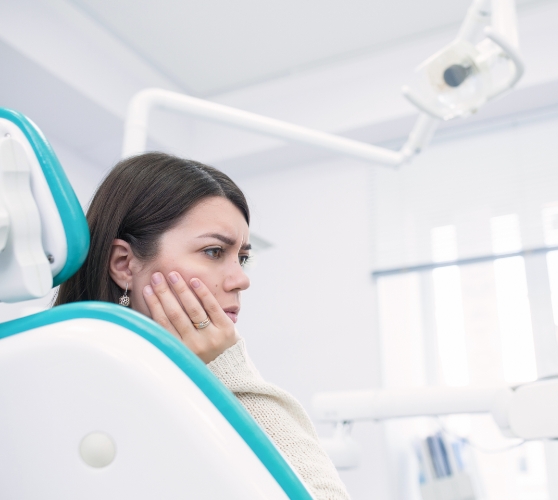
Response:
402,0,524,120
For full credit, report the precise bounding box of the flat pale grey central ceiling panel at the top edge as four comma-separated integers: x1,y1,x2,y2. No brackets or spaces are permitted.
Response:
71,0,541,96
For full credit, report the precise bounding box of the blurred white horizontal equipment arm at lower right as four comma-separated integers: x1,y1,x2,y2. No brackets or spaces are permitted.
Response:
312,375,558,439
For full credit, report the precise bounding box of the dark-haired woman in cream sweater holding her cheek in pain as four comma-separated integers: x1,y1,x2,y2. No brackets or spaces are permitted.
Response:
55,153,348,500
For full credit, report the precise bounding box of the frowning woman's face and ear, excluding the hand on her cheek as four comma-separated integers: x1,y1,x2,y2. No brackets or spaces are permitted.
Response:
130,197,250,322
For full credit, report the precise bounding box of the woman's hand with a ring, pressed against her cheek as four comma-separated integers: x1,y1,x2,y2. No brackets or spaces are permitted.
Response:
143,271,239,363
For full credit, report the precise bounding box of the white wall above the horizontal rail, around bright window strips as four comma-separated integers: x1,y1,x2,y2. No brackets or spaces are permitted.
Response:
372,113,558,269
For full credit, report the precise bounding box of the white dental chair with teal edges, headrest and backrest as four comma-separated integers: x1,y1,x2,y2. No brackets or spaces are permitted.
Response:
0,109,312,500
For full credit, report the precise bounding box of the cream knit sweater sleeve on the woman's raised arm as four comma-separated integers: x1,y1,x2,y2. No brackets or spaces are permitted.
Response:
207,339,349,500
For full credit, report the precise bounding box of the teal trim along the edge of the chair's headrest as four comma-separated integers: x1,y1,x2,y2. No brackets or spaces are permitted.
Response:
0,108,89,286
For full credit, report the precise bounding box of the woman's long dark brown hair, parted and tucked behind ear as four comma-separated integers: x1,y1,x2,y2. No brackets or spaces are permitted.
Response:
54,153,250,306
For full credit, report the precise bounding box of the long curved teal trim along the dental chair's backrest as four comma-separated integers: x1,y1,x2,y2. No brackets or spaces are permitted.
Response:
0,302,312,500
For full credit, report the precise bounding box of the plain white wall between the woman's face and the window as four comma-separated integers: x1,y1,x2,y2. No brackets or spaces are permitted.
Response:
239,160,389,500
